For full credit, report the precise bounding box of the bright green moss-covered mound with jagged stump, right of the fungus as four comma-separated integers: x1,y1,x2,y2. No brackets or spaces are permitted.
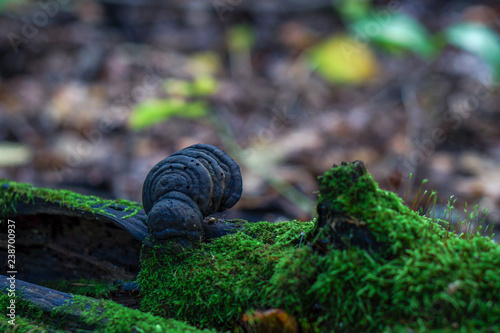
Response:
139,163,500,332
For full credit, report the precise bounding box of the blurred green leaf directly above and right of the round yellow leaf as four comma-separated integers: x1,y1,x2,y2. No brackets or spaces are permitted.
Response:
351,11,435,59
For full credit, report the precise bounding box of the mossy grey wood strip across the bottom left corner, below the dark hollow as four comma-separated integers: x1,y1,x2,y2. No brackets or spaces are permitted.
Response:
0,275,213,333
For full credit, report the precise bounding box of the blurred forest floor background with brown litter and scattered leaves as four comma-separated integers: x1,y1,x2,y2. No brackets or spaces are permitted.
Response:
0,0,500,239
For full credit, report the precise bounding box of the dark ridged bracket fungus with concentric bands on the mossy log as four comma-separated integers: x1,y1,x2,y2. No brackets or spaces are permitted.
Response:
142,144,242,247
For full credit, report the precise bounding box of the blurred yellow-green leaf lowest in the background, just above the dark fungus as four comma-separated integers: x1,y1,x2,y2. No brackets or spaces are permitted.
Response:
128,98,208,131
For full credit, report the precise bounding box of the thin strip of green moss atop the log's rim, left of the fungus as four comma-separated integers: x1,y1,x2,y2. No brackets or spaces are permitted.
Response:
0,179,142,218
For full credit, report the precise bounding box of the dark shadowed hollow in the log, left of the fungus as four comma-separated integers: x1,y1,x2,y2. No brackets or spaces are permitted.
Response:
0,214,142,283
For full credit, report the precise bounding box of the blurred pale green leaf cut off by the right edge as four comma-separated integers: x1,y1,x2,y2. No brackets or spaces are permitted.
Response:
445,23,500,79
